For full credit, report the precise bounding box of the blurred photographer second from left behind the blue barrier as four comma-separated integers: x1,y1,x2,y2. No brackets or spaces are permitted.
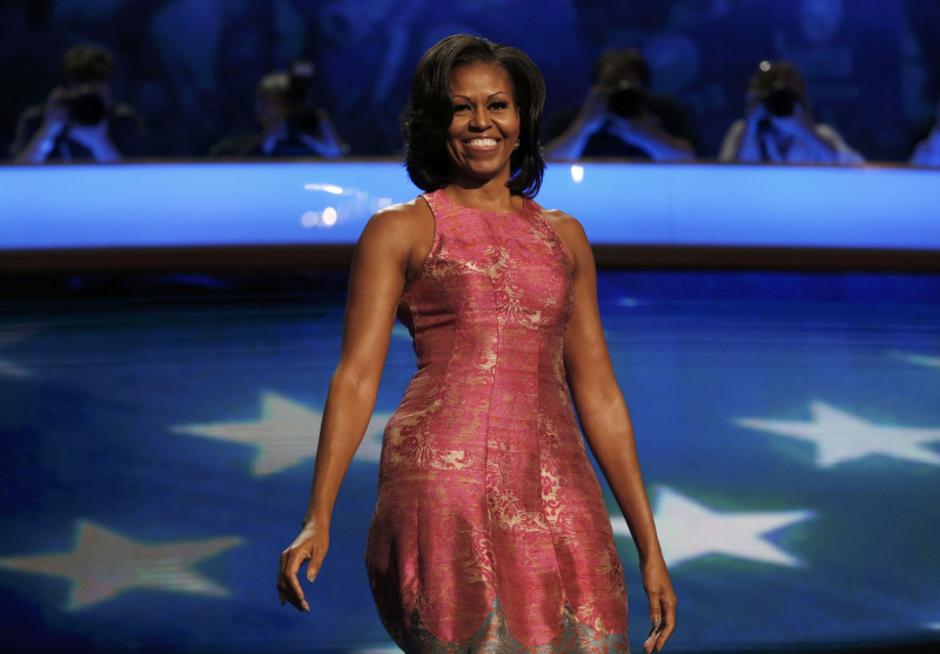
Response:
209,61,349,157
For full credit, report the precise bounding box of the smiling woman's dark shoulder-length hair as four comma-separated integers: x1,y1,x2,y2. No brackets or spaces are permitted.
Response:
402,34,545,198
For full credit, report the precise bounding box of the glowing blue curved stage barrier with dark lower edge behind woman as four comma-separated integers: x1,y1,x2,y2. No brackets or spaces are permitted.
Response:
0,161,940,270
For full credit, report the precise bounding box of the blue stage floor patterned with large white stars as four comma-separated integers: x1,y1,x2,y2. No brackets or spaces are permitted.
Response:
0,271,940,653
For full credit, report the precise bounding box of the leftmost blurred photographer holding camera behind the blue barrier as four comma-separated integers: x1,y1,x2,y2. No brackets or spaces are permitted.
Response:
10,44,144,163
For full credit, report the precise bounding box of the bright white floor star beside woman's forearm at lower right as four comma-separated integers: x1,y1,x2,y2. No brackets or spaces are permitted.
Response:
611,487,814,567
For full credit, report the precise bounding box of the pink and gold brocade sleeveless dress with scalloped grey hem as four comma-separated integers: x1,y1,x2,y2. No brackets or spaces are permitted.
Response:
365,190,629,654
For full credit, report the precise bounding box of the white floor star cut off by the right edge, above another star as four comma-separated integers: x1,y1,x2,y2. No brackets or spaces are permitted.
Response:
735,402,940,468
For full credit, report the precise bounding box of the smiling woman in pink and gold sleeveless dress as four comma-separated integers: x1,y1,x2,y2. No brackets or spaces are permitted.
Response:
278,35,676,652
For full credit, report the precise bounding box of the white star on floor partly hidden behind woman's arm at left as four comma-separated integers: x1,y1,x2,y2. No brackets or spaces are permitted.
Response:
170,391,390,477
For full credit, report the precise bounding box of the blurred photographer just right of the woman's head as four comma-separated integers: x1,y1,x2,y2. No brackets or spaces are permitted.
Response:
545,48,695,161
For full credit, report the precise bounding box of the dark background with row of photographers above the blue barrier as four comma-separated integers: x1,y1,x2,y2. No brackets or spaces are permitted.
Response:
0,0,940,166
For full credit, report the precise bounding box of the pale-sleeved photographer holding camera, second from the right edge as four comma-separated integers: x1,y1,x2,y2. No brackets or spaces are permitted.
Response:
718,61,865,164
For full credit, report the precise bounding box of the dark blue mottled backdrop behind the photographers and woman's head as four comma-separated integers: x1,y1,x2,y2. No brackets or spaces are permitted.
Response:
0,0,940,160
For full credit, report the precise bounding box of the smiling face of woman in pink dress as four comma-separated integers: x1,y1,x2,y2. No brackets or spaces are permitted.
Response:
447,63,519,181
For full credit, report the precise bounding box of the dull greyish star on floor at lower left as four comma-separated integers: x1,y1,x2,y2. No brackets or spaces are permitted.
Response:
0,520,242,611
